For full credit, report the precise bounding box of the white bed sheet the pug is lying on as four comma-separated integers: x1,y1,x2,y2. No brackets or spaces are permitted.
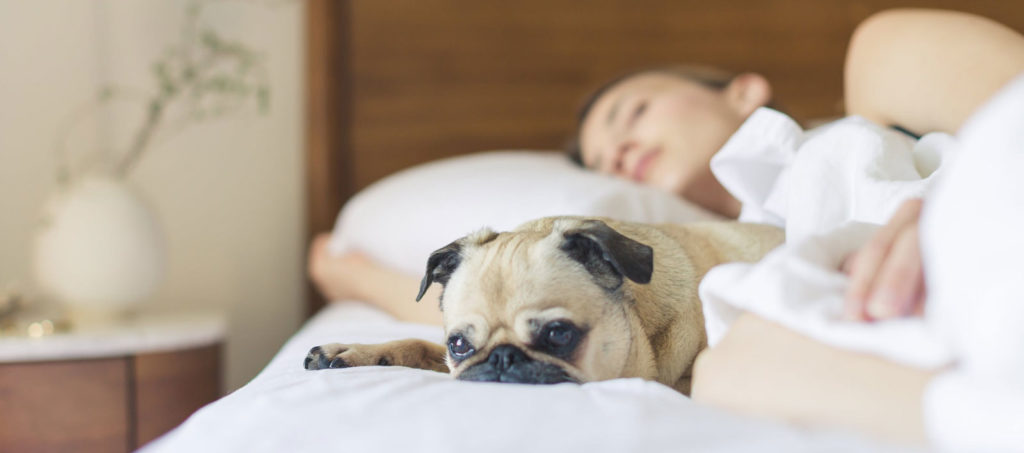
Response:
143,302,929,453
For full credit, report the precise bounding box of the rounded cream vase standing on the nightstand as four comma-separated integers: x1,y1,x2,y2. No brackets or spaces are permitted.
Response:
34,175,165,322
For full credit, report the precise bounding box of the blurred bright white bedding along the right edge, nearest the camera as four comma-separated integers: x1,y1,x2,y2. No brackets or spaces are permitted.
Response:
921,75,1024,451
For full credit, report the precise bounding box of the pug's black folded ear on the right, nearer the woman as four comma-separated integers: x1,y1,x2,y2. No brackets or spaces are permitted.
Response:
558,219,654,290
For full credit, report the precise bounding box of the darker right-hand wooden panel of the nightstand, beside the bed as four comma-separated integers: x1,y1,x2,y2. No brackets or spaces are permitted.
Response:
132,344,221,448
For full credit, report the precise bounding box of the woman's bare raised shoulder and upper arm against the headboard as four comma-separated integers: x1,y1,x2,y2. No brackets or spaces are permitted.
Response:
845,9,1024,134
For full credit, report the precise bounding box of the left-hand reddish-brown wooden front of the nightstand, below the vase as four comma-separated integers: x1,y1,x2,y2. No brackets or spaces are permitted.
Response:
0,359,134,453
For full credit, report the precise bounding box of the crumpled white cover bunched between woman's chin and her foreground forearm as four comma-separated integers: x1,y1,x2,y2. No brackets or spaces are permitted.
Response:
700,109,955,367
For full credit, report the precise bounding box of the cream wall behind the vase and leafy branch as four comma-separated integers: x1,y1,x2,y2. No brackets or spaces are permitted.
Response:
0,0,305,389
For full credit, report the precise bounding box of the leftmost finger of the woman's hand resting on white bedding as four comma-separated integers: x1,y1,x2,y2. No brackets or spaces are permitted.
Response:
843,199,922,321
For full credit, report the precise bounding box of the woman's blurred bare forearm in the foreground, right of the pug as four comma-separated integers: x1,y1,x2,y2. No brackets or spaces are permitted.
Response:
692,314,932,443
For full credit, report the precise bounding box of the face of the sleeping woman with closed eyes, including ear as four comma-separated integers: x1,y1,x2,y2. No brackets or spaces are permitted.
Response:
580,72,767,216
